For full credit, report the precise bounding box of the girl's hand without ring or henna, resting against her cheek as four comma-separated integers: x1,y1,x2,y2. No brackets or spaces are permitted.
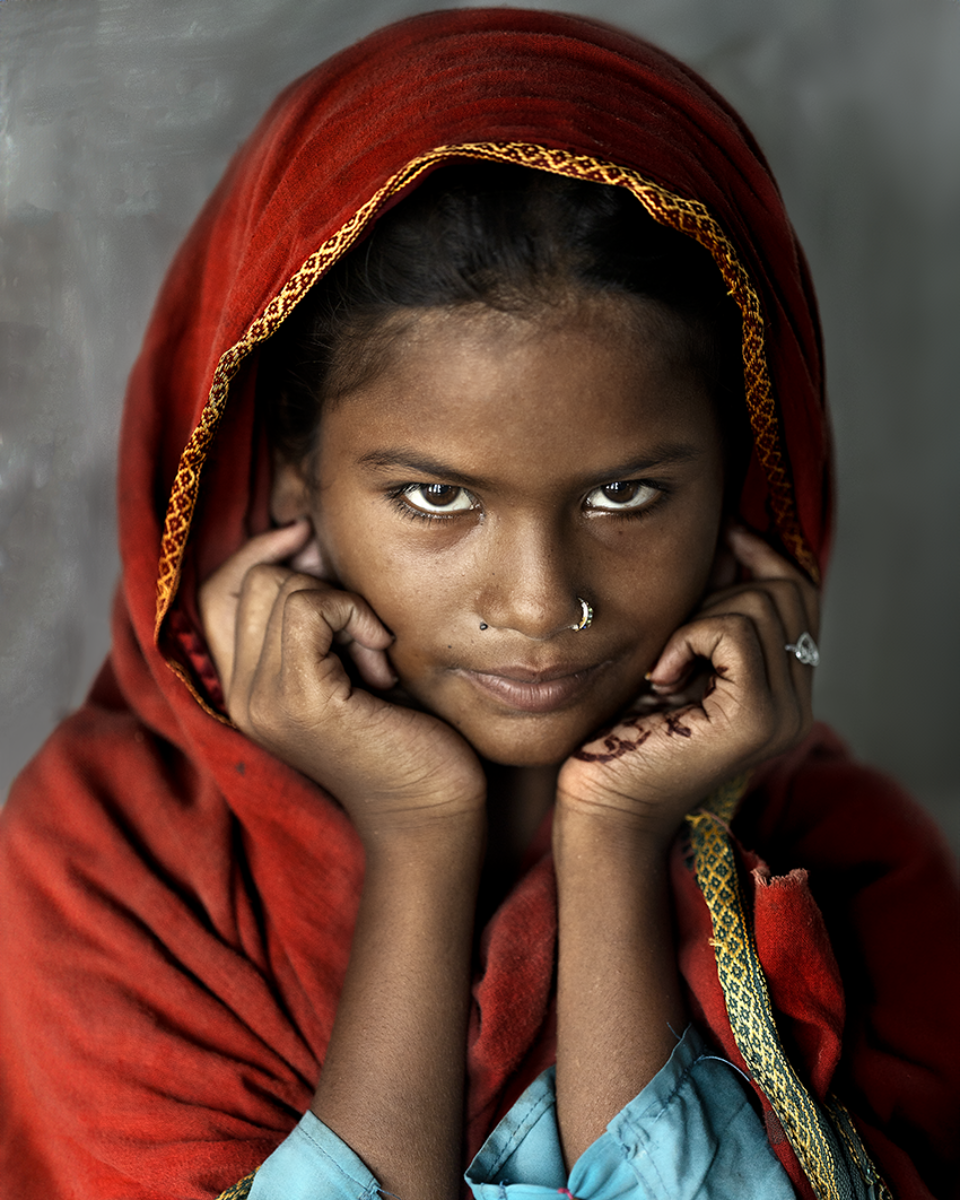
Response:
199,521,485,844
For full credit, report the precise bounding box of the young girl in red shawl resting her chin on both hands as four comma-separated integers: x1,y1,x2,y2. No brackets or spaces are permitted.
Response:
0,10,958,1200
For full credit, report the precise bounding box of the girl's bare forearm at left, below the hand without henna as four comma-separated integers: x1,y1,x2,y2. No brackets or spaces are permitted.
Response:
312,818,484,1200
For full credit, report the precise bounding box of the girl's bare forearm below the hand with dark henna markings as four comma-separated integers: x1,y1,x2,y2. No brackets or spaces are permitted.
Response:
554,804,686,1169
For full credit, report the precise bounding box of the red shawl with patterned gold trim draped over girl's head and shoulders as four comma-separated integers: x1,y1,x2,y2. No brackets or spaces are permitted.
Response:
0,10,959,1200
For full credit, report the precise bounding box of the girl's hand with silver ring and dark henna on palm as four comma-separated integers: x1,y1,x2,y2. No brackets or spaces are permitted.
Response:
558,528,820,847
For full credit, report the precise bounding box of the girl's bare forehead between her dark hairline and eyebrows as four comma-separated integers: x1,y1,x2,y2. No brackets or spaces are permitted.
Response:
320,296,720,475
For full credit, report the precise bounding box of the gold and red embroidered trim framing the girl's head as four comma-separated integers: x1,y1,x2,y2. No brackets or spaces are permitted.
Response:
155,142,818,637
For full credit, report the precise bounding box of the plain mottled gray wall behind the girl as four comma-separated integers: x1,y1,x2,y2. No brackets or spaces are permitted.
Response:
0,0,960,846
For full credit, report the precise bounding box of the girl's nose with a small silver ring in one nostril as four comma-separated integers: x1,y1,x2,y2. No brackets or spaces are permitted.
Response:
479,528,582,641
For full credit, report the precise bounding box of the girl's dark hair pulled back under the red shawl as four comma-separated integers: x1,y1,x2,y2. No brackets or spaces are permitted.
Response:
257,163,750,482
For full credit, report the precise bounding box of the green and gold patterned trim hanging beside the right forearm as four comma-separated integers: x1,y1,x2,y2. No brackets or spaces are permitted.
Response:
686,779,892,1200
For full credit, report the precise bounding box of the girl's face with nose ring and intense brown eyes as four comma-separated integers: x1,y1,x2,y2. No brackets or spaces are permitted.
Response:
285,296,724,766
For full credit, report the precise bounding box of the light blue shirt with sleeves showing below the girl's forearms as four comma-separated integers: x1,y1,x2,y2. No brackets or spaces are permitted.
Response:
250,1026,794,1200
